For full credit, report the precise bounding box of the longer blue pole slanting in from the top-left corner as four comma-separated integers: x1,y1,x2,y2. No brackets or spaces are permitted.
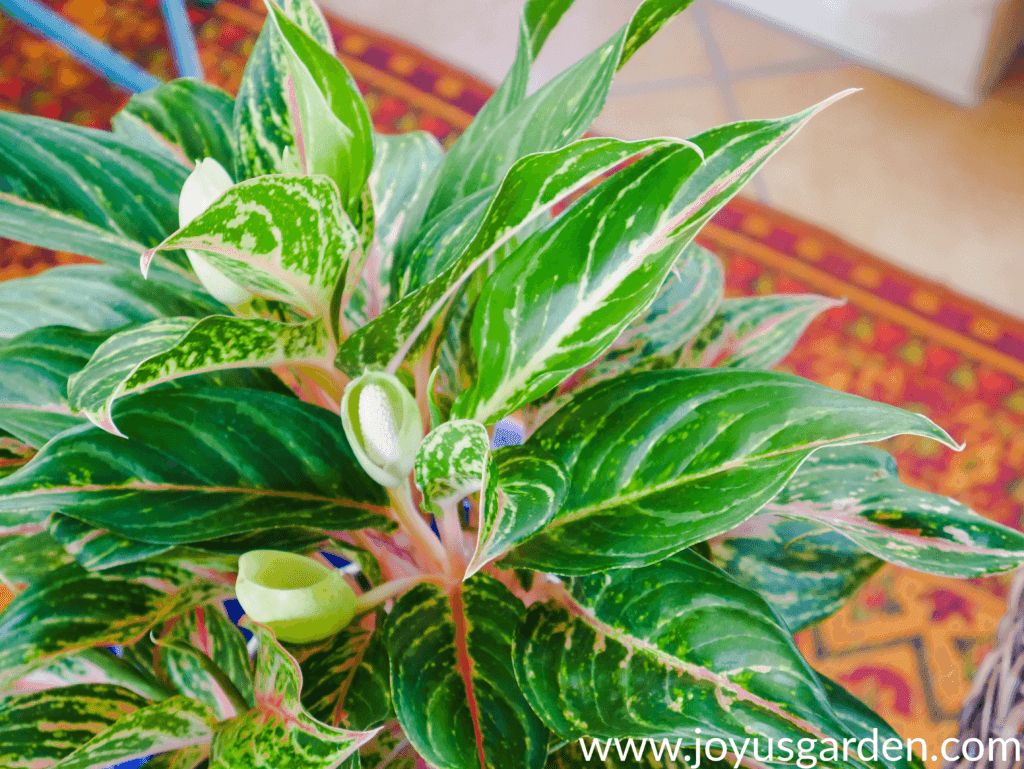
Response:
0,0,161,93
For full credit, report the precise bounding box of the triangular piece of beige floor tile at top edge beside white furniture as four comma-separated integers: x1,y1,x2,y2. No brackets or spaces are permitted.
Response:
700,2,835,72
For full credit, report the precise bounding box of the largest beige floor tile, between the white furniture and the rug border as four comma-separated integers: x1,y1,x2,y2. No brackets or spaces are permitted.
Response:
735,67,1024,315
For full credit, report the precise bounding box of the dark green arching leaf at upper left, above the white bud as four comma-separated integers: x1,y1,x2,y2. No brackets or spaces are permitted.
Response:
111,78,234,171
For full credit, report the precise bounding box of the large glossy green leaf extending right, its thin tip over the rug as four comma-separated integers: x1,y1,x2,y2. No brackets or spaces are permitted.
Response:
509,369,959,574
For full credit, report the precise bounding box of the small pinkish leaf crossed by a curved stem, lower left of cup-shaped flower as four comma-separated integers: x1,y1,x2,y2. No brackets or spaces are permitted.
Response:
157,604,253,719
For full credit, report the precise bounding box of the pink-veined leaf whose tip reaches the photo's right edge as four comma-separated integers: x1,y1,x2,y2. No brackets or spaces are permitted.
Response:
764,447,1024,578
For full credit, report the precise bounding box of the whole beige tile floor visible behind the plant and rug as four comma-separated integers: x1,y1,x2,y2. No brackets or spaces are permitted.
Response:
322,0,1024,316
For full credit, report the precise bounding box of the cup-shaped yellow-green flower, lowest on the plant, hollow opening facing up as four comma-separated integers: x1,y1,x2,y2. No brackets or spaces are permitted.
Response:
234,550,355,643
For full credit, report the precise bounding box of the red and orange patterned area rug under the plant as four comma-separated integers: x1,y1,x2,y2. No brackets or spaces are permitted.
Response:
0,0,1024,752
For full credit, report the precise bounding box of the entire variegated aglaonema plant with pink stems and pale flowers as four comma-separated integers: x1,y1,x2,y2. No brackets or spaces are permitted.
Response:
0,0,1024,769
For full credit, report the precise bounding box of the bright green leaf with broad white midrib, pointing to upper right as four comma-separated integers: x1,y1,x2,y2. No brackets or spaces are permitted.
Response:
452,94,845,424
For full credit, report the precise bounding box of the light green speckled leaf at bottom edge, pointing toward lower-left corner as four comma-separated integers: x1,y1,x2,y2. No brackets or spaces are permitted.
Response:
53,696,216,769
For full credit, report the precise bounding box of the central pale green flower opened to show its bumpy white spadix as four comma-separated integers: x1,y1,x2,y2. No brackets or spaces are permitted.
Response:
341,373,423,488
